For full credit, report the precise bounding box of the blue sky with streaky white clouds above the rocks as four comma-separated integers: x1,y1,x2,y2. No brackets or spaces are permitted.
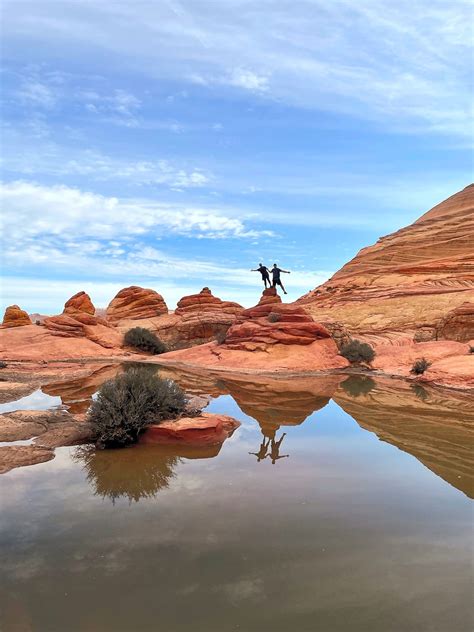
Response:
0,0,474,314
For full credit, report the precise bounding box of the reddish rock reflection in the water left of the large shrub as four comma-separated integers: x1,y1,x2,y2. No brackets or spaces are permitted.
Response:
41,364,122,415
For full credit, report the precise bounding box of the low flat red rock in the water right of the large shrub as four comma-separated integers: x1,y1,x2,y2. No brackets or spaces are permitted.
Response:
140,413,240,446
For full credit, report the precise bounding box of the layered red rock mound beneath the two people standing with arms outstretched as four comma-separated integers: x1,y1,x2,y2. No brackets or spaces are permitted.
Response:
224,302,331,351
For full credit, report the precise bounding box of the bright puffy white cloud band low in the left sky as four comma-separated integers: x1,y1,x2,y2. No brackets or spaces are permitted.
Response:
0,183,272,248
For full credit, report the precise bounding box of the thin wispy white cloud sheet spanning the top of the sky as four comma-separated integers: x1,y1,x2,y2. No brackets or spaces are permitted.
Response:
3,0,472,137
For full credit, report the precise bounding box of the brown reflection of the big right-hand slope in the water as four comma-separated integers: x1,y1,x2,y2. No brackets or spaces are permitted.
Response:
334,380,474,498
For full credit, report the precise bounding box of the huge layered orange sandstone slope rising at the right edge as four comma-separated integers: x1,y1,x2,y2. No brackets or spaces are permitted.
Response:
297,185,474,342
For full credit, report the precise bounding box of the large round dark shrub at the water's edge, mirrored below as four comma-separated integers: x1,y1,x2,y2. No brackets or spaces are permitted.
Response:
89,368,186,447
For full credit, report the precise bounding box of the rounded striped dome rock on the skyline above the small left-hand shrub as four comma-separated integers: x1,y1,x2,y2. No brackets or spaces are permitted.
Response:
106,285,168,323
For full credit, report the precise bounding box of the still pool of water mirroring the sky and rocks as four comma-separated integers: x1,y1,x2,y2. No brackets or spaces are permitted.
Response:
0,371,474,632
